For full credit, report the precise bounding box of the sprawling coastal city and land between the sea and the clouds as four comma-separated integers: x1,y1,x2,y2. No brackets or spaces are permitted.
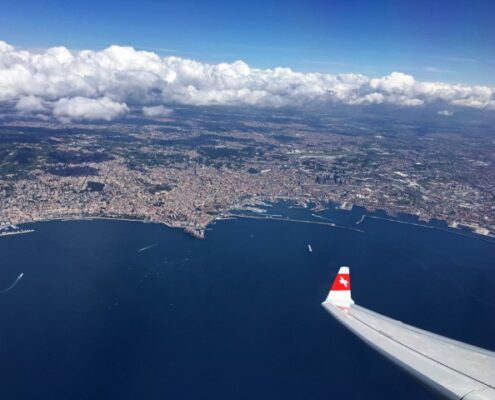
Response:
0,108,495,237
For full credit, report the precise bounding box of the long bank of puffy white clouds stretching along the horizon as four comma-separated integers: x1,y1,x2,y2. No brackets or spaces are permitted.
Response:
0,41,495,121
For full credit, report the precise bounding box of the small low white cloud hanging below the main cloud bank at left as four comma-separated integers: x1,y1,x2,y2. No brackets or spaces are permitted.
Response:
53,96,128,122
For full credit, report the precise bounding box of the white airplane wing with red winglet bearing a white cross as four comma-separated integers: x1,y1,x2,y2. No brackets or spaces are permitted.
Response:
322,267,495,400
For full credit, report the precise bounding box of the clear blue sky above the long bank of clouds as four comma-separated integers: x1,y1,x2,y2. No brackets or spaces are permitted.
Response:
0,0,495,86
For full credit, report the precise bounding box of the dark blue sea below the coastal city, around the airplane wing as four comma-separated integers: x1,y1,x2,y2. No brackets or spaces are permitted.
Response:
0,204,495,400
